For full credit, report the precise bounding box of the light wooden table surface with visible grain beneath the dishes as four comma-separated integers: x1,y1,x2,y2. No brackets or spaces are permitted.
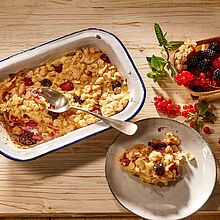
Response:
0,0,220,219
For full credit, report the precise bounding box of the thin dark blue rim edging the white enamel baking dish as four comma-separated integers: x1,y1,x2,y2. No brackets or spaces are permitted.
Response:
0,28,146,162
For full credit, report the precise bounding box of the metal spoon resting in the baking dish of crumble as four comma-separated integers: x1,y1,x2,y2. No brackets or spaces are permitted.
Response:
39,88,138,135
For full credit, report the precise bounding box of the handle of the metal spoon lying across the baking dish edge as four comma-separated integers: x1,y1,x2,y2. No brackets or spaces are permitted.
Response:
70,106,138,135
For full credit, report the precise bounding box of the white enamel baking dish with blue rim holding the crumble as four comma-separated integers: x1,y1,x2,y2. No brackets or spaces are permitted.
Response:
0,28,146,161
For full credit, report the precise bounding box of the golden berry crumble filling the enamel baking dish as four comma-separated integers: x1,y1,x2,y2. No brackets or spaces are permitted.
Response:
0,48,129,148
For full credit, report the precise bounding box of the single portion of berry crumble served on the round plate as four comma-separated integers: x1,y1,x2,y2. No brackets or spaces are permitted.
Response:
118,132,194,185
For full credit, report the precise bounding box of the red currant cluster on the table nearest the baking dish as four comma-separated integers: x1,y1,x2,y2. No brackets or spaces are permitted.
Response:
154,96,181,116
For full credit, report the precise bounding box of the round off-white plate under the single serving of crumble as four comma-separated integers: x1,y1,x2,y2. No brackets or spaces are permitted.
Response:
106,118,216,220
